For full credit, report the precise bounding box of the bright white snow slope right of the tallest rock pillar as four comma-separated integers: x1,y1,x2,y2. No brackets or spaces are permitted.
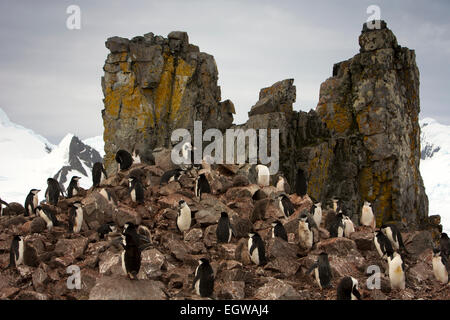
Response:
419,118,450,233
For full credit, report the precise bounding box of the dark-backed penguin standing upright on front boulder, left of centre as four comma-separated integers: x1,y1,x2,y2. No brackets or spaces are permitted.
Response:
122,223,142,280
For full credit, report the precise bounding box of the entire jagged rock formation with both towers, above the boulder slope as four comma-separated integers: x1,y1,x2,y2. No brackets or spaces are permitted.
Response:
103,21,428,230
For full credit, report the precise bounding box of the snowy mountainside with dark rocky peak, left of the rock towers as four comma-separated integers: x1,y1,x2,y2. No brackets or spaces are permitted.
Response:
0,109,102,204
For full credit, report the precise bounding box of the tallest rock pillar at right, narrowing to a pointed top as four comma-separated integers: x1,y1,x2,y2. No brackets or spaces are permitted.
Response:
316,22,428,226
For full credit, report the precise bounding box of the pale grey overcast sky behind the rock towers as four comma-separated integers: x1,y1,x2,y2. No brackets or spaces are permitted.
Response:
0,0,450,143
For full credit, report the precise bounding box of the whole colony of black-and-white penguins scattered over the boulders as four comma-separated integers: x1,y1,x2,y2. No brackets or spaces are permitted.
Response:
0,148,450,300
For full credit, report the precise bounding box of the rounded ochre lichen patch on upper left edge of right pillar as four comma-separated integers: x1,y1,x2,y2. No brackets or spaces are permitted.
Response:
316,103,352,134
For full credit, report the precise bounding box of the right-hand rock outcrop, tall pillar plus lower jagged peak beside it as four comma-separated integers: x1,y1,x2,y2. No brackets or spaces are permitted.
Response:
237,22,428,228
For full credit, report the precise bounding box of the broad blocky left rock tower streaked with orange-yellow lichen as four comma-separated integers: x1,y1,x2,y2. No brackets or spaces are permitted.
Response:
102,31,234,172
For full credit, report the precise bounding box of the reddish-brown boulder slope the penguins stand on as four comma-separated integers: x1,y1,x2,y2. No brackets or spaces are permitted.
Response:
0,164,450,300
